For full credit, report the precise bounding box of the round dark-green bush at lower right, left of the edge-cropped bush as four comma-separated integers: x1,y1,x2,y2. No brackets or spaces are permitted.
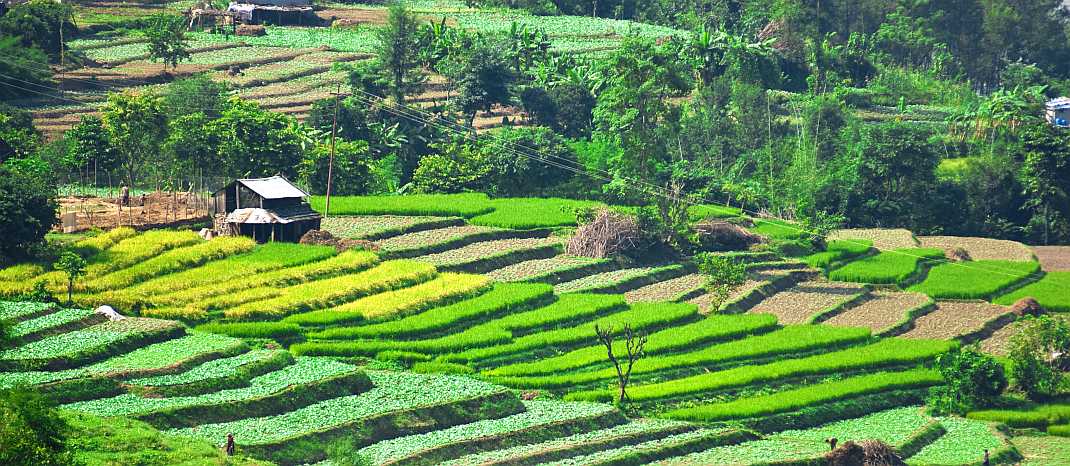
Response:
926,347,1007,415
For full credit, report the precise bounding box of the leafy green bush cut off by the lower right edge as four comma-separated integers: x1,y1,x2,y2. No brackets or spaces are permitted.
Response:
1009,316,1070,400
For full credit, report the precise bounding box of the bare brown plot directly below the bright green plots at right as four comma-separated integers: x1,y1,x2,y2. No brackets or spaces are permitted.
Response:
902,301,1010,339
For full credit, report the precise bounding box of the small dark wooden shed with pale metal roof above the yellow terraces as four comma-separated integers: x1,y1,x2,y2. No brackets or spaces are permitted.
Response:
211,175,322,243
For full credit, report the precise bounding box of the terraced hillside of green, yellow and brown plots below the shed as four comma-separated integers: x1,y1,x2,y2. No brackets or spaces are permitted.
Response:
0,198,1066,464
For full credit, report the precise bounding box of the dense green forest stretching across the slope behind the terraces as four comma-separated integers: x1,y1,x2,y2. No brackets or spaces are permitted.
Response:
0,0,1070,261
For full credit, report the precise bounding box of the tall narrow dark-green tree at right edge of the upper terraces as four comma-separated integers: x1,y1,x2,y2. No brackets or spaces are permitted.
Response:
376,1,425,104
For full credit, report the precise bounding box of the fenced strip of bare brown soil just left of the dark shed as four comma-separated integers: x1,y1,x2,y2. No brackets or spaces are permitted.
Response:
56,192,211,232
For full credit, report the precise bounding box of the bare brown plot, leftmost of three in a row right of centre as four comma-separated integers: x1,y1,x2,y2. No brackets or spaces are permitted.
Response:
747,281,867,324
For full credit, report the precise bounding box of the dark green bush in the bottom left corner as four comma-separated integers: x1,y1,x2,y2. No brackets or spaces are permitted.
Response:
0,389,73,466
